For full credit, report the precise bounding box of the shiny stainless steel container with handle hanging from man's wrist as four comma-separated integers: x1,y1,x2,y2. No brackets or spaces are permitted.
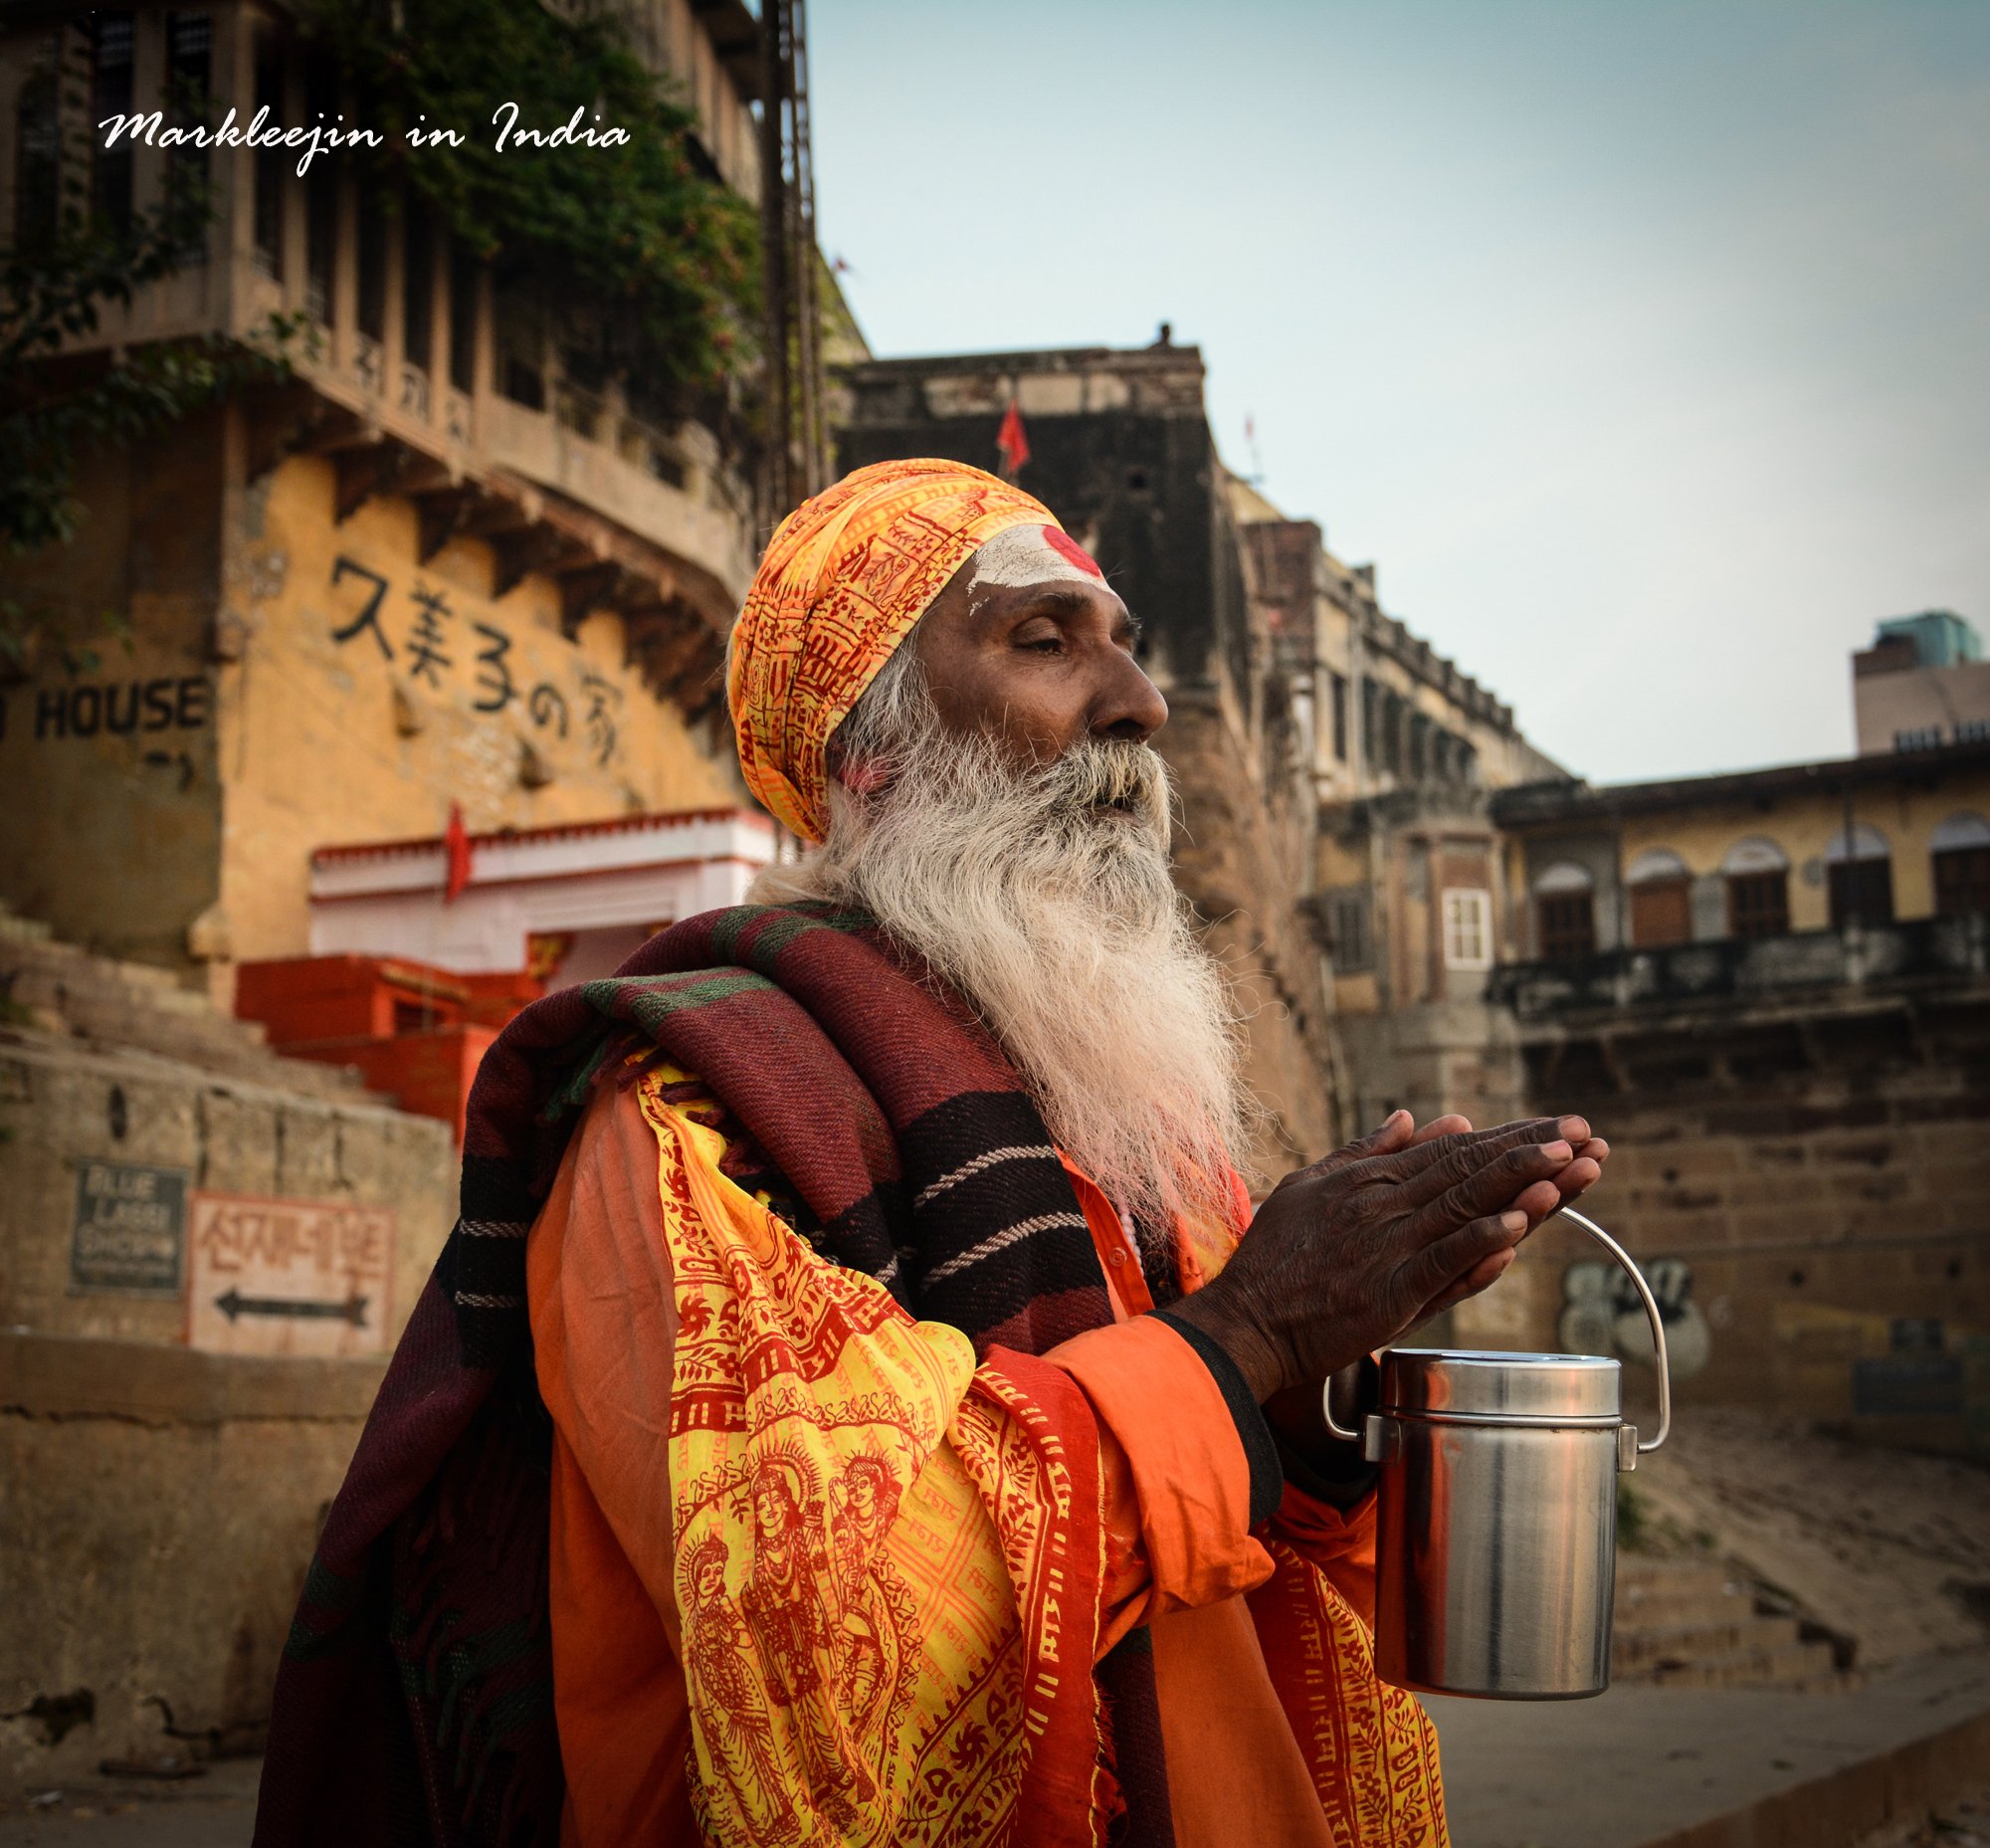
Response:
1327,1207,1672,1701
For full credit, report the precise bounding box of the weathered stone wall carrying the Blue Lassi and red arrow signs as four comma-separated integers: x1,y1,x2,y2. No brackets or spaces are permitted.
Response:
0,920,456,1788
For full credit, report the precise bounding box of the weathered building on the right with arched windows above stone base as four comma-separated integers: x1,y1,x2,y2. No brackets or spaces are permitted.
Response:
1485,744,1990,1452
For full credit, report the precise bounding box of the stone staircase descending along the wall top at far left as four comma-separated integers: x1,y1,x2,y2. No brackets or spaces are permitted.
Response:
0,906,386,1104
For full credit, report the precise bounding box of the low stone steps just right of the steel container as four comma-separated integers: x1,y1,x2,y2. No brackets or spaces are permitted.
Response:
1610,1553,1857,1689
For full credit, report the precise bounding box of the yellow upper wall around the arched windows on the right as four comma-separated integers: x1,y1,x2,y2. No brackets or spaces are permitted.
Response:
1622,772,1990,930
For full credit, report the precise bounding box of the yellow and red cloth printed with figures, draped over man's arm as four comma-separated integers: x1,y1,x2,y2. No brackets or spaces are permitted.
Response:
639,1068,1102,1848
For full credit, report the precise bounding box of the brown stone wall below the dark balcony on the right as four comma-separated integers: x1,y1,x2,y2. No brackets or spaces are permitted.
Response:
1459,988,1990,1456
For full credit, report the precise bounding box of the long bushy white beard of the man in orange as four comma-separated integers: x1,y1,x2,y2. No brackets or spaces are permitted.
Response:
752,647,1256,1227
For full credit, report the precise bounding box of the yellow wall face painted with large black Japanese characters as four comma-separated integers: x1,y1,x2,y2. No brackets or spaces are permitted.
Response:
217,456,746,958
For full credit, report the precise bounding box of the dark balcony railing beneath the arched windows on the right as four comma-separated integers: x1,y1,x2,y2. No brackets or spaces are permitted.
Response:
1487,912,1990,1020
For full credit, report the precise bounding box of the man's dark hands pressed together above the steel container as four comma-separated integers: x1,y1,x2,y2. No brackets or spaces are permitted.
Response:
1174,1112,1610,1402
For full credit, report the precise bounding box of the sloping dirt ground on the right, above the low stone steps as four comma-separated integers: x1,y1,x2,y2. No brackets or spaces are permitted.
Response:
1622,1406,1990,1669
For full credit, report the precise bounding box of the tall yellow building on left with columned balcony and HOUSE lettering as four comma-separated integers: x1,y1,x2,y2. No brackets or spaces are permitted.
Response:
0,0,852,1004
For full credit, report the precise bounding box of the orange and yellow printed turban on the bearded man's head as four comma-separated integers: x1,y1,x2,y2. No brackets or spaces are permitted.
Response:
726,458,1061,840
